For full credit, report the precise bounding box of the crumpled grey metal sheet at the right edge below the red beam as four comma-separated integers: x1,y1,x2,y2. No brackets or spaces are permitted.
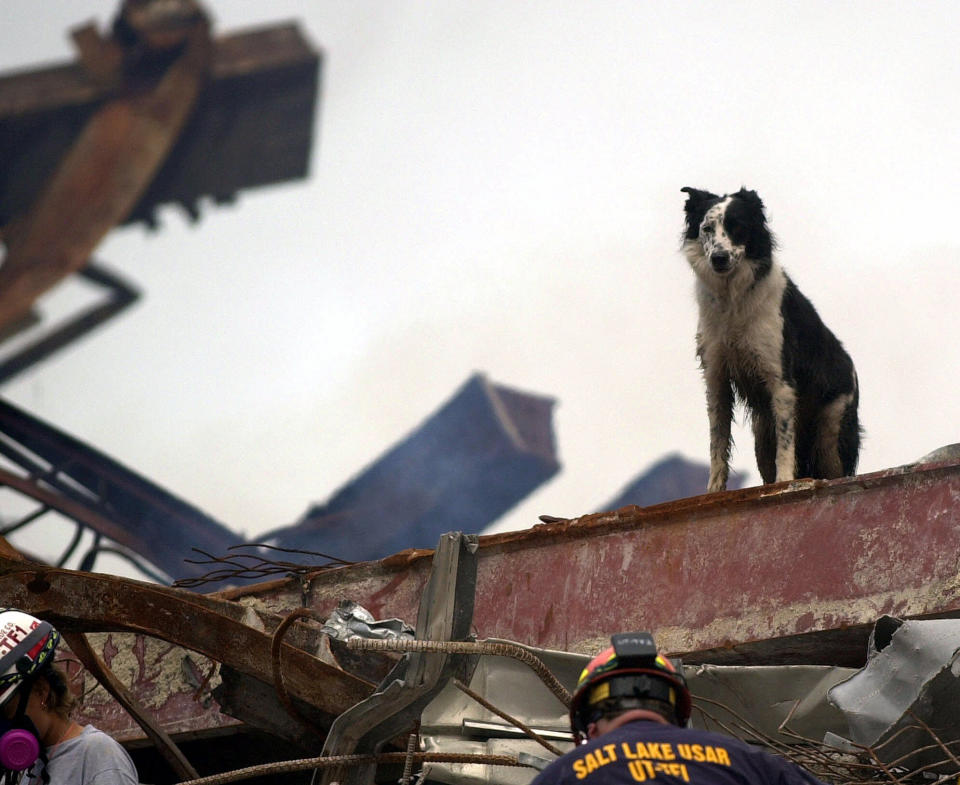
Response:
825,616,960,769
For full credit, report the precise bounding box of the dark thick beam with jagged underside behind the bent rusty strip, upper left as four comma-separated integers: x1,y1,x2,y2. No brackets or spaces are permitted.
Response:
0,23,321,233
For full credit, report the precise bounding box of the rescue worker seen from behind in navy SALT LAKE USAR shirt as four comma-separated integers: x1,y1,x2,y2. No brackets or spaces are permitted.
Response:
532,632,822,785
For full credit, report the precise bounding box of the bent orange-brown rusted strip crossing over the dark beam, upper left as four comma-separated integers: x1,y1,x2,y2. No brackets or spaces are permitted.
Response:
0,16,210,326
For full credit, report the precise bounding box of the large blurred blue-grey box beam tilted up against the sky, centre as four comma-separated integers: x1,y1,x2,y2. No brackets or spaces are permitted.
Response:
261,374,560,561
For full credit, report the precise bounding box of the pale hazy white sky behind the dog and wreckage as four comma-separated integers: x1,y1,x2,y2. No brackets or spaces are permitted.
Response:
0,0,960,564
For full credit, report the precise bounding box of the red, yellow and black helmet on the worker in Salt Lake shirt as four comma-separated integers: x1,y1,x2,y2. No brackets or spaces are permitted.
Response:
570,632,691,739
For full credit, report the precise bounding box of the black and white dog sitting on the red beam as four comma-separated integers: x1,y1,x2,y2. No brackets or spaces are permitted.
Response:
682,188,860,491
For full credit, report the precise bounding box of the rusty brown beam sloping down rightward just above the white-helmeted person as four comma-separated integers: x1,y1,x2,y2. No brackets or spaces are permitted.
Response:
0,555,372,719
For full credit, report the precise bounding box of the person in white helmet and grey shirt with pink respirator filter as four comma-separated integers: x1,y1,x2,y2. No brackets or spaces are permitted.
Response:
0,608,137,785
